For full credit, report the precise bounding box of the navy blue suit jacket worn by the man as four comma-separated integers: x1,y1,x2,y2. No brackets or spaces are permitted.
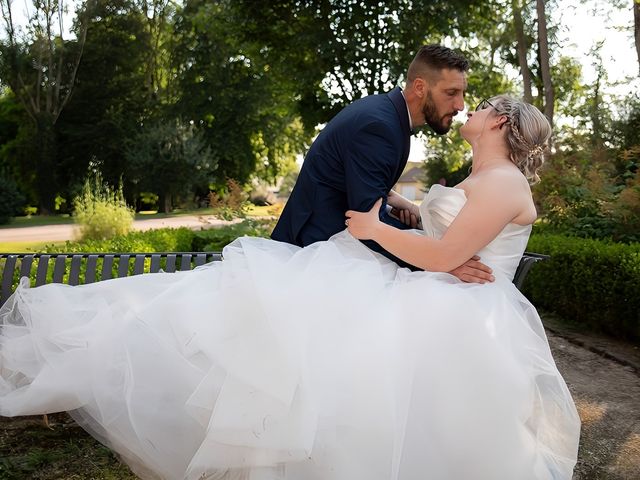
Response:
271,88,411,266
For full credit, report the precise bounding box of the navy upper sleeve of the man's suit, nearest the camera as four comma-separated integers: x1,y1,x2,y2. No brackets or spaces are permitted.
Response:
345,122,398,212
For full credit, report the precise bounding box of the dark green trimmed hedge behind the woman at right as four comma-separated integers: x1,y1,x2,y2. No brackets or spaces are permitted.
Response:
524,234,640,342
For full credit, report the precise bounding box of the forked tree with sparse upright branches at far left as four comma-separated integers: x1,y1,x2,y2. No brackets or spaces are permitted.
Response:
0,0,93,214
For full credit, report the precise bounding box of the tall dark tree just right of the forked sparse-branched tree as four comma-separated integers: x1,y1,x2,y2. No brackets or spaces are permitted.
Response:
57,0,153,197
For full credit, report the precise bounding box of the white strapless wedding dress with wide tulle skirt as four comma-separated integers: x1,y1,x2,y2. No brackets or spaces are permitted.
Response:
0,185,580,480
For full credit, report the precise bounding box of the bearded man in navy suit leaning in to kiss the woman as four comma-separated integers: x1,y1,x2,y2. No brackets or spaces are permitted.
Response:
271,45,490,281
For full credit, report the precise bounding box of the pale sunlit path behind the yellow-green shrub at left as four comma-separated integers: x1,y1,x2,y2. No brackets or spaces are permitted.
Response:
0,215,231,248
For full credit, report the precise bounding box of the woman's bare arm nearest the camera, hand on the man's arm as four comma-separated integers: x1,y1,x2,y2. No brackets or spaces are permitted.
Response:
346,178,526,272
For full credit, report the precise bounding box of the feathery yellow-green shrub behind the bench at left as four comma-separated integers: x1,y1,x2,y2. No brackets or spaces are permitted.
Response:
73,173,134,240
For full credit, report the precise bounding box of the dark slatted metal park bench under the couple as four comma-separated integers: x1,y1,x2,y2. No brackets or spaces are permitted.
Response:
0,252,547,306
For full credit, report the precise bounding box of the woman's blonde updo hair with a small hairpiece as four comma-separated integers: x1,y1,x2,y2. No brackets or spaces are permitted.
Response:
490,95,551,184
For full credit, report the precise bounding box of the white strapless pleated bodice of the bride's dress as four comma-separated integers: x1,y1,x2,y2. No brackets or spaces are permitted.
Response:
420,184,531,281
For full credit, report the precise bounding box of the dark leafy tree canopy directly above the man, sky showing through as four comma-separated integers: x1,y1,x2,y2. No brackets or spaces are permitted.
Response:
228,0,499,128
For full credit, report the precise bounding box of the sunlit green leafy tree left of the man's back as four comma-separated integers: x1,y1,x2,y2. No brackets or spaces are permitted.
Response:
171,0,304,186
